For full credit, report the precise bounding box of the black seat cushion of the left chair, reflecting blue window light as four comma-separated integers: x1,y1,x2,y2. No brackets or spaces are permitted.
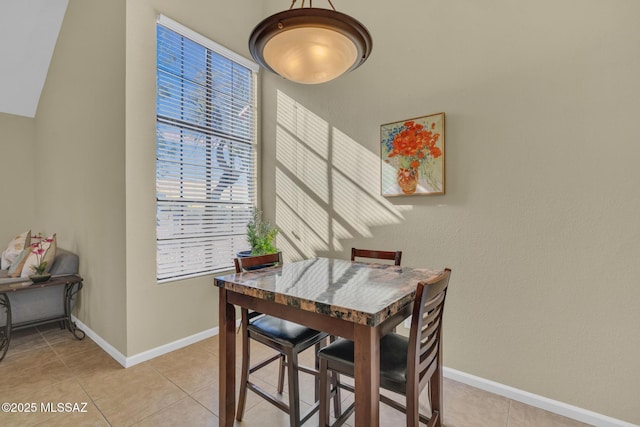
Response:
247,315,327,347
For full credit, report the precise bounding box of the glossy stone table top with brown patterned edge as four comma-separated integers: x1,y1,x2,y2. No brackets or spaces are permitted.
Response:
215,258,442,326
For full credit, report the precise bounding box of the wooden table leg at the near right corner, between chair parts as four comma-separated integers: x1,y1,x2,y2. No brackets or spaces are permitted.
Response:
354,324,380,427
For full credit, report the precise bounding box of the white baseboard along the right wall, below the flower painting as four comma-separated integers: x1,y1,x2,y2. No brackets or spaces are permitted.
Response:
442,367,639,427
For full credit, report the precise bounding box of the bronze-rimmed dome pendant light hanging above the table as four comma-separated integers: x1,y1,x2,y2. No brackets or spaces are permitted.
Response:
249,0,372,84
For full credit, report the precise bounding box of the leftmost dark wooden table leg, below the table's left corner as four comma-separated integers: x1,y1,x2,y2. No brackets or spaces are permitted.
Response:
218,288,236,427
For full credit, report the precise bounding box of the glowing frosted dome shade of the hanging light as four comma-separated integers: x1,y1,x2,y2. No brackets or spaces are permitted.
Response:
263,27,358,84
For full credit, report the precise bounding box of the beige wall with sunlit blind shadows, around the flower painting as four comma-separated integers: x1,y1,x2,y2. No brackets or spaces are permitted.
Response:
262,0,640,423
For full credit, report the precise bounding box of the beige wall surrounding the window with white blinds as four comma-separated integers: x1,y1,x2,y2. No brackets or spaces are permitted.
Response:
126,0,260,355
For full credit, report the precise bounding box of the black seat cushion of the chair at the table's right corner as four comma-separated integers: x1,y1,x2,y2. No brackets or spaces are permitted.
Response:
318,333,409,394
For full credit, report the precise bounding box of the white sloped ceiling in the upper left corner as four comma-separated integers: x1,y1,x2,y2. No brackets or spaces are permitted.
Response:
0,0,68,117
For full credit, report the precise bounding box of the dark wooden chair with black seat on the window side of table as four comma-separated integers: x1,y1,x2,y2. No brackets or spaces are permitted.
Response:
234,252,328,427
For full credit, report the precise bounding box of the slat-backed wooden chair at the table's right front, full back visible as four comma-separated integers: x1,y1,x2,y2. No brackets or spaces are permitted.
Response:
318,268,451,427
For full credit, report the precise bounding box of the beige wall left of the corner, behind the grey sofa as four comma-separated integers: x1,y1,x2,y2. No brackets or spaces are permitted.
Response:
35,0,127,354
